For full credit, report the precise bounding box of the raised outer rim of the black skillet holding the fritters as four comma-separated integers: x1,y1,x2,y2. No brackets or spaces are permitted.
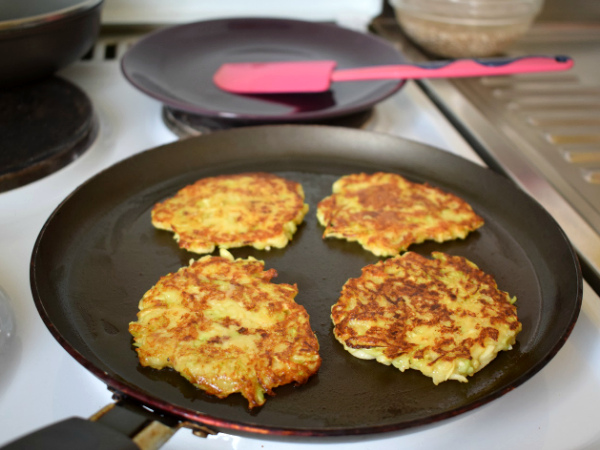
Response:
30,125,583,436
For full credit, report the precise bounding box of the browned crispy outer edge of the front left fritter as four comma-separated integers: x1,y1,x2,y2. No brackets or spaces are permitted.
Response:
129,250,322,409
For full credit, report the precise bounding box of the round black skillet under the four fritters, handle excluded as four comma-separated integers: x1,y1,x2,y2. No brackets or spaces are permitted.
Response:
22,125,582,448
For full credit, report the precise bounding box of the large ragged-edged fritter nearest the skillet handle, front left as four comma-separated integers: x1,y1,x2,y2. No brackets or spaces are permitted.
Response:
129,250,321,408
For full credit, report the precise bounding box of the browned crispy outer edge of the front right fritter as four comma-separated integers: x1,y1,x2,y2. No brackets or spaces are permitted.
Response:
331,252,522,385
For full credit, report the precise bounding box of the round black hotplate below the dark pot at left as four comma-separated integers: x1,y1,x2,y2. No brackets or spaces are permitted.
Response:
0,77,99,192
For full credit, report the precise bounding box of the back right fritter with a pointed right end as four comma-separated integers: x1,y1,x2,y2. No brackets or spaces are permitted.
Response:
317,172,484,256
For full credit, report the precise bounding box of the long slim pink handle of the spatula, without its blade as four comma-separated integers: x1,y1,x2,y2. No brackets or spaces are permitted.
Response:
331,56,573,81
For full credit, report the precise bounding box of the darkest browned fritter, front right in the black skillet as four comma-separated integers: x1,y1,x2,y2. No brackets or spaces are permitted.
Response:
331,252,522,385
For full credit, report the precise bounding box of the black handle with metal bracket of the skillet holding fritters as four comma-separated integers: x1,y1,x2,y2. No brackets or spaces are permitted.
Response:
1,398,216,450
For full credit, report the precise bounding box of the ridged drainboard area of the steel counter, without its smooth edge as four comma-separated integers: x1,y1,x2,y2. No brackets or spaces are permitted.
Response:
440,26,600,233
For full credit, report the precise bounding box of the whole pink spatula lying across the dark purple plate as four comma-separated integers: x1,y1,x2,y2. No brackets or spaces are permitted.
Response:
213,56,573,94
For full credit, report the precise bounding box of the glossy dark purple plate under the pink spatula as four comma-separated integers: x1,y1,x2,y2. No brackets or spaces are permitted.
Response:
121,18,406,122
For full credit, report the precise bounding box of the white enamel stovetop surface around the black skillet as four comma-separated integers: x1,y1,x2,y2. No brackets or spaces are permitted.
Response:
0,30,600,450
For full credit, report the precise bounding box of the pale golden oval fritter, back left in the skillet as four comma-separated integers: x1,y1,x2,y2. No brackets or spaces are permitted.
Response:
152,173,308,254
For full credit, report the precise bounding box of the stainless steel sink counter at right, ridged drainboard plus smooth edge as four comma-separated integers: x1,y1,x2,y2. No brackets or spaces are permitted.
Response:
376,14,600,296
